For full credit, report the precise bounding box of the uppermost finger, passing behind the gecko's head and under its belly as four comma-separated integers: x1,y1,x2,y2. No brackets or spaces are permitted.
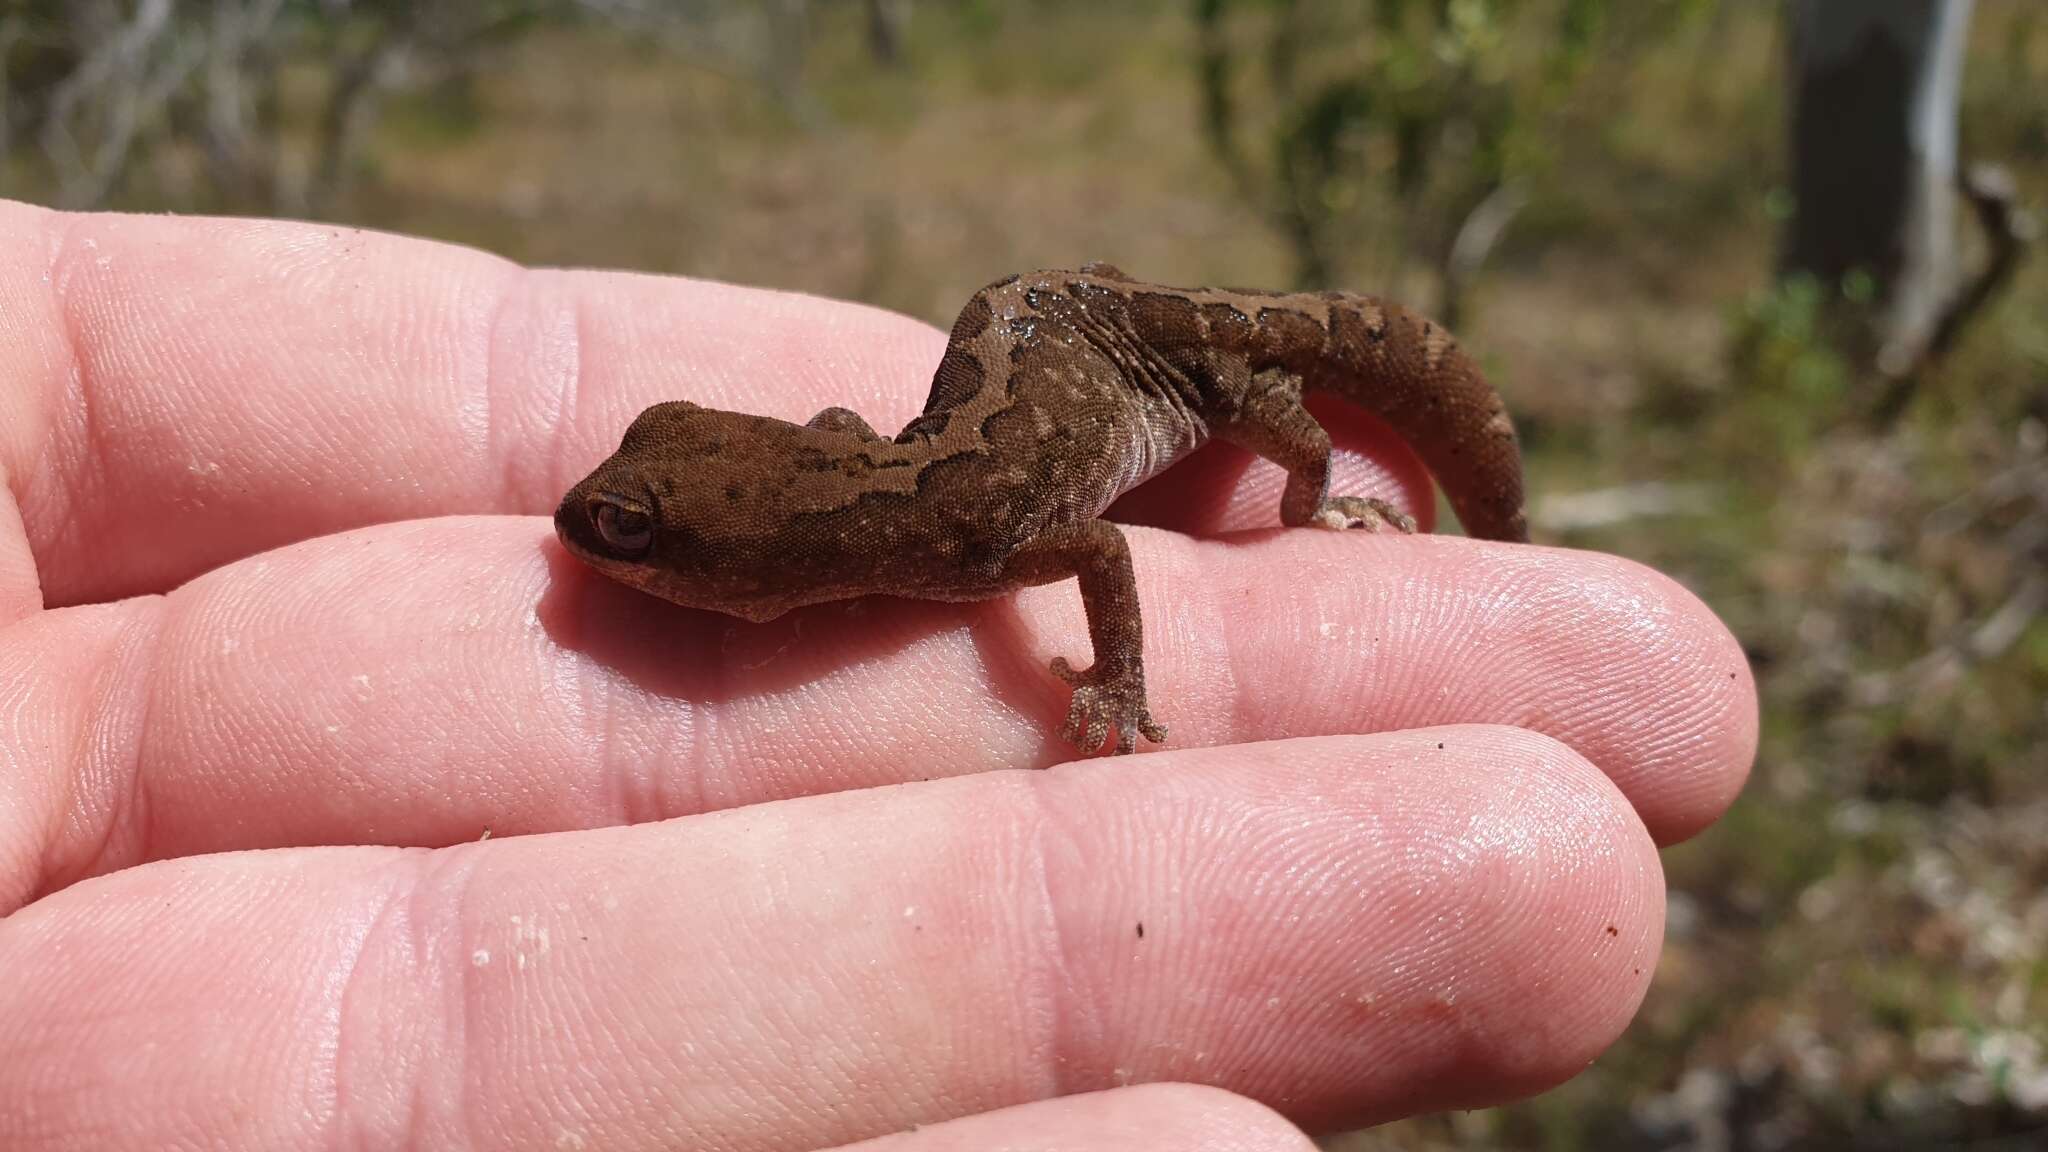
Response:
0,203,1427,619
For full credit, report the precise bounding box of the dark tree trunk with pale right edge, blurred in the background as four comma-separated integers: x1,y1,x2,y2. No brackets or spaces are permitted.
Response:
1782,0,1972,367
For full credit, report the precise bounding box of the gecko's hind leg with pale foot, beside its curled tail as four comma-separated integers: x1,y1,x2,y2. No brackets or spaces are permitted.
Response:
1217,369,1415,533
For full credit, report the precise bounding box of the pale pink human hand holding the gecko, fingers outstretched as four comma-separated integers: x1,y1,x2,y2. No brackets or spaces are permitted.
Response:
0,205,1755,1152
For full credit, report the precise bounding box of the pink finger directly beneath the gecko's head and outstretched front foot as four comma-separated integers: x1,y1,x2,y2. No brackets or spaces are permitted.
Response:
0,517,1755,900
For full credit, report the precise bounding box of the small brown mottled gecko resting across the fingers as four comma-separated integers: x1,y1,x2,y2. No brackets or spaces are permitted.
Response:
555,264,1528,752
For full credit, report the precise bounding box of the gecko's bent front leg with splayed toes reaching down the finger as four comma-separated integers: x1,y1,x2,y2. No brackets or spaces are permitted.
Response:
1004,521,1165,754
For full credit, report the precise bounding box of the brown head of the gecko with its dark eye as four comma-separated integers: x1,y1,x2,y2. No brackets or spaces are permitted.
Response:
555,402,823,621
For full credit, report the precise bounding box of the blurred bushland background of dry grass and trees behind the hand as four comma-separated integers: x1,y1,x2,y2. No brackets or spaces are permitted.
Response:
0,0,2048,1150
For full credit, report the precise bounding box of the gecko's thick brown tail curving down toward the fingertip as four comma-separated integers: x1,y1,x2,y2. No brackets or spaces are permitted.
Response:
1288,293,1530,541
